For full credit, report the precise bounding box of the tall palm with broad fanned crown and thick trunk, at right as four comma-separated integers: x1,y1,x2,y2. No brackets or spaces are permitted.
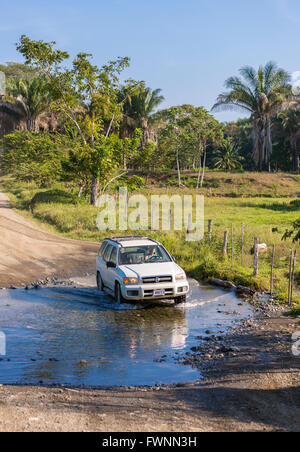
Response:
213,62,292,171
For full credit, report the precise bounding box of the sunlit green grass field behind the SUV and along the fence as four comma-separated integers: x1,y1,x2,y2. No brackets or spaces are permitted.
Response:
1,173,300,303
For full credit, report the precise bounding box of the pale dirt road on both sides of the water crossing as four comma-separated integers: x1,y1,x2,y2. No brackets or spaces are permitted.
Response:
0,193,300,432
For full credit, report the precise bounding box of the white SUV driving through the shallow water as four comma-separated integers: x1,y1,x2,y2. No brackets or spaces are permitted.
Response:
96,236,189,304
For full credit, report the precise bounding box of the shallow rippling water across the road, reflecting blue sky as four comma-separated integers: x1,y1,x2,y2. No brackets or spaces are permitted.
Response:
0,278,252,386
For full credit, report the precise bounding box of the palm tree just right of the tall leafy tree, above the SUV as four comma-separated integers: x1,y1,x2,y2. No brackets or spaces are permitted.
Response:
124,85,164,146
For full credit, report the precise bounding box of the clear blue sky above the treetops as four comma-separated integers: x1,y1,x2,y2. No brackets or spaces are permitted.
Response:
0,0,300,121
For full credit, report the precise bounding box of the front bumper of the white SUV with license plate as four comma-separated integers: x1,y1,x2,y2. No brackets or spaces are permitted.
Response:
121,280,189,301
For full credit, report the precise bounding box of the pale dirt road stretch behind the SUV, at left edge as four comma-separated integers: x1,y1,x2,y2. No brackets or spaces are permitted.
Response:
0,192,98,287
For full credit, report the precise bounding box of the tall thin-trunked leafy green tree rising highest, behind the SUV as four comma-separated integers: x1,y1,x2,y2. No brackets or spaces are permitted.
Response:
17,35,136,205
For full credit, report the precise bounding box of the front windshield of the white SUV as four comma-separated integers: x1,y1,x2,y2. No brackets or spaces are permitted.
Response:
119,245,172,265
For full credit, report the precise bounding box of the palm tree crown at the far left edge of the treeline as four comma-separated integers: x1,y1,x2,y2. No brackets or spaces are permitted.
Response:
0,77,50,132
